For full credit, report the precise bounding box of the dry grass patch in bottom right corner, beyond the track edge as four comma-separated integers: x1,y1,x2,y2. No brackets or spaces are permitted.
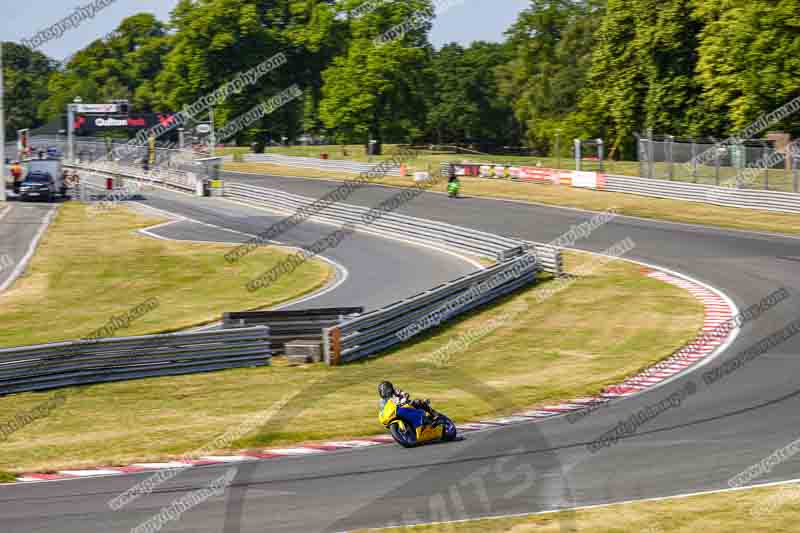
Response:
361,484,800,533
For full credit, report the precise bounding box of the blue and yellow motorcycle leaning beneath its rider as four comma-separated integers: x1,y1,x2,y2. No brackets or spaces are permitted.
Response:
378,400,456,448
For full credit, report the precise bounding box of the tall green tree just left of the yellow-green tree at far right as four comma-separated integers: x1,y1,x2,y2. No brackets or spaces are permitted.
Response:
581,0,702,157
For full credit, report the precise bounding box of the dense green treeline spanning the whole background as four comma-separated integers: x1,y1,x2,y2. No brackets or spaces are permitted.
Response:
5,0,800,157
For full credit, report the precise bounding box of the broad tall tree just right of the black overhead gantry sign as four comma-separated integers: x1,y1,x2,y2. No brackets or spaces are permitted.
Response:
154,0,348,143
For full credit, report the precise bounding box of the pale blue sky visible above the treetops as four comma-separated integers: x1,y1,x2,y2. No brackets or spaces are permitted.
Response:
0,0,529,60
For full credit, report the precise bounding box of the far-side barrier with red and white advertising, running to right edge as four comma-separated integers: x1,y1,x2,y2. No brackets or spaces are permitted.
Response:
442,163,800,213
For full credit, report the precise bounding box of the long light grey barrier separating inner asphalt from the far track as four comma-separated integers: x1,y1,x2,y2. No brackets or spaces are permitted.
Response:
225,182,563,275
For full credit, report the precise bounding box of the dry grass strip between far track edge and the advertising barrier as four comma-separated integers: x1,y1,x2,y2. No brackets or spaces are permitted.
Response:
225,163,800,235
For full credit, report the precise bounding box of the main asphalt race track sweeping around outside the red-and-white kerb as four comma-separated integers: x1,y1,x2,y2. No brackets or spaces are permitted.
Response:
0,174,800,533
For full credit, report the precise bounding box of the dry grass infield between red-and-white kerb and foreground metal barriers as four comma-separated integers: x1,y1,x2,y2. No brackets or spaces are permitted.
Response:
0,249,702,472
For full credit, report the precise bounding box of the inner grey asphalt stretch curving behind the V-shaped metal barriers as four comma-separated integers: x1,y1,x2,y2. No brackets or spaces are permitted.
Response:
89,177,476,311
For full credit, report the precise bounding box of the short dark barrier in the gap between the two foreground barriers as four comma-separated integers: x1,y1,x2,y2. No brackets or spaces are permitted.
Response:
223,307,364,355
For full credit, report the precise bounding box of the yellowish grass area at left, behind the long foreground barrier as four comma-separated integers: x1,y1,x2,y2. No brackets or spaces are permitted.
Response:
0,203,333,348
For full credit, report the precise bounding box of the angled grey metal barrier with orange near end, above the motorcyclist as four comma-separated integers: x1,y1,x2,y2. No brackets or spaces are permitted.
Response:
323,254,541,365
